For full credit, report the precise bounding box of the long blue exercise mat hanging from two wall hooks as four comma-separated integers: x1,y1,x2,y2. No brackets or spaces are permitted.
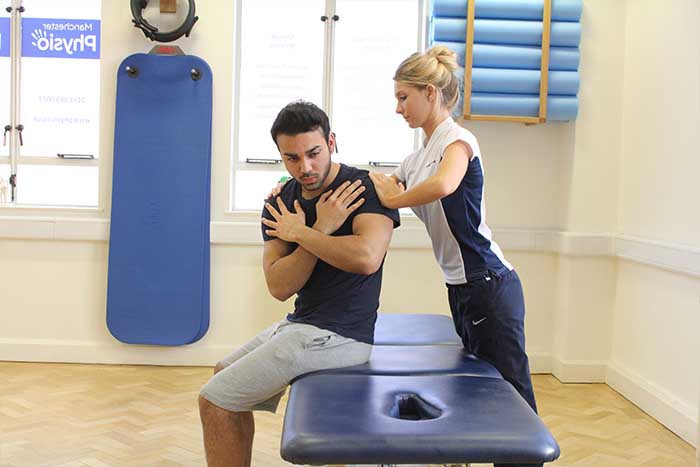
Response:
107,54,212,345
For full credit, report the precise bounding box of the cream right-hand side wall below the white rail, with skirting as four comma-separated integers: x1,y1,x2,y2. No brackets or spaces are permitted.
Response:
608,261,700,442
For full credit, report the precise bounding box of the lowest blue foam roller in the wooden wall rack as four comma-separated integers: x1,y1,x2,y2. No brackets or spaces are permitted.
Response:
454,93,578,121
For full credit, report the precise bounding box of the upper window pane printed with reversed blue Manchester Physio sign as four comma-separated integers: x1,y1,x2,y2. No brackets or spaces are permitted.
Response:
20,13,100,158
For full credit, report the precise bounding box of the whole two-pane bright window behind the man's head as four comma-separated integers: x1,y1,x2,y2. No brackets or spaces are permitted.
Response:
231,0,424,211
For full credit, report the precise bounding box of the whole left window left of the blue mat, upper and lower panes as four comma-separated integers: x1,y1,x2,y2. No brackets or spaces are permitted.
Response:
0,0,101,206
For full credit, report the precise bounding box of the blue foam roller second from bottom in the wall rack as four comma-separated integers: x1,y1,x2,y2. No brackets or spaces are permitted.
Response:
455,68,579,96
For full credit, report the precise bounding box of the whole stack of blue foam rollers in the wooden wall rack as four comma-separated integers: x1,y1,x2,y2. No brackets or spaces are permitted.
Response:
429,0,582,121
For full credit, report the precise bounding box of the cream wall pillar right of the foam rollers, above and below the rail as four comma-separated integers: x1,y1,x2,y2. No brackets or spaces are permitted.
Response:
553,0,625,381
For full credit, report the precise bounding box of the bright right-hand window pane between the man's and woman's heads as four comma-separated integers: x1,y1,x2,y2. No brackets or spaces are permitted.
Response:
333,0,419,165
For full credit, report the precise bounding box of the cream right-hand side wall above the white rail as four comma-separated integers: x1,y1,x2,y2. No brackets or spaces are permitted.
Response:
618,0,700,248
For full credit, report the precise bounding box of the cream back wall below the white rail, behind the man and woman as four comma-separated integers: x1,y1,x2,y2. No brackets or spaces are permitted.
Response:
0,239,556,372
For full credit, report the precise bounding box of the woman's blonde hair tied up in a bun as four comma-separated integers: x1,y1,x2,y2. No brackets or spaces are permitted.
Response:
394,45,459,111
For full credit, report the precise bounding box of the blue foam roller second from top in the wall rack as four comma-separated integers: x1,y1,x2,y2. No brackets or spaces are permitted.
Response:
428,17,581,47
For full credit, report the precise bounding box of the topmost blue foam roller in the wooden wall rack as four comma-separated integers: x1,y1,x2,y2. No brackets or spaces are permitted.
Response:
431,0,583,21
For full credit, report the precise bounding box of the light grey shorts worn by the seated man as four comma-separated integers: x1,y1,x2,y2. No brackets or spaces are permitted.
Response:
200,319,372,412
